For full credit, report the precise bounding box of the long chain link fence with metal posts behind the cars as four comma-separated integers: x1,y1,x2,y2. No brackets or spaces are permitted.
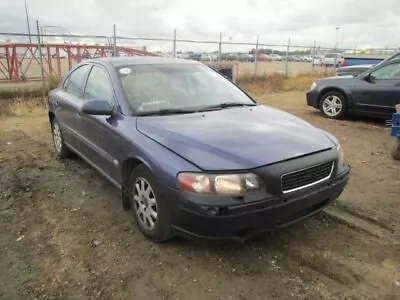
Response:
0,22,397,89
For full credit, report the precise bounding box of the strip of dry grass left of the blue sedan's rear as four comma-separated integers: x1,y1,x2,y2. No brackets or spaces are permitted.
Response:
0,98,46,117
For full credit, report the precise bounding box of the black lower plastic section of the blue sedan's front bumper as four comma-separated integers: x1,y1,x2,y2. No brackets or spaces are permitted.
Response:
171,172,349,241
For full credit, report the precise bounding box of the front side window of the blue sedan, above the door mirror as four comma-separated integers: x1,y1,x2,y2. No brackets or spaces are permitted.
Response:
83,66,115,105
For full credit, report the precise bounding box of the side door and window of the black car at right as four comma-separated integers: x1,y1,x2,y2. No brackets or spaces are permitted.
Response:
352,61,400,117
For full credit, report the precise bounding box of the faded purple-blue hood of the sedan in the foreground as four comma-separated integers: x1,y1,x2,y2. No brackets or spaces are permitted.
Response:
137,105,334,170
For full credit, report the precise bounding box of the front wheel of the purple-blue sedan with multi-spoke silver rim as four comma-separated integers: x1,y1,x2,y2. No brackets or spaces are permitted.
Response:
129,165,173,242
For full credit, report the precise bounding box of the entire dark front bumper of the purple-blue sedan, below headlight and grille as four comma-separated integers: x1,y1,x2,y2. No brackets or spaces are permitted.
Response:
164,167,350,240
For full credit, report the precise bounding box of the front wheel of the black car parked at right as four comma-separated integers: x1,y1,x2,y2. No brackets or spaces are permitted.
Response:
319,91,347,119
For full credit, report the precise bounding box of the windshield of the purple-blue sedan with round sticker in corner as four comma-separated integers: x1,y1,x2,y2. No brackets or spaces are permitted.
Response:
118,64,254,115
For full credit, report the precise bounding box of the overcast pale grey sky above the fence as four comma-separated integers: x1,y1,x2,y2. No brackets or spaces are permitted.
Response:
0,0,400,51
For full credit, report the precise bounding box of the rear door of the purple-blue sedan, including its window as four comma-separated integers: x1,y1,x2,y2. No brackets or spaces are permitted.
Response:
52,64,90,151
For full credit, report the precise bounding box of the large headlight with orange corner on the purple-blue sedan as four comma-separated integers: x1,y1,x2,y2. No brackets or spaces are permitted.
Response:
178,173,263,196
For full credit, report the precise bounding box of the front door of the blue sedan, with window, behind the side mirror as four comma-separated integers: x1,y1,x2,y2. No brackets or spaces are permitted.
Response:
78,64,121,183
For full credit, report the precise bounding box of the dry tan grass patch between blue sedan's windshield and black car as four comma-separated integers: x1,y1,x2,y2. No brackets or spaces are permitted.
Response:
237,73,332,94
